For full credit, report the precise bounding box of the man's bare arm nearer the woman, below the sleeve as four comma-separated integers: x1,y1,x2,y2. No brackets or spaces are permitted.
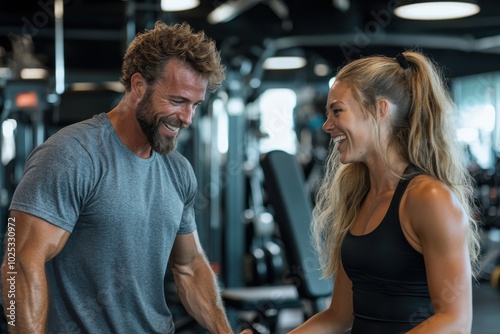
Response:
170,232,232,333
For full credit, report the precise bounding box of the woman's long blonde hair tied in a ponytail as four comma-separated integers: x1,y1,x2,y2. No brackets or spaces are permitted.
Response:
312,51,479,277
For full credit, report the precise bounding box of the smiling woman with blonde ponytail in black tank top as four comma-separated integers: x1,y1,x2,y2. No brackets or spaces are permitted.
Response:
291,52,479,334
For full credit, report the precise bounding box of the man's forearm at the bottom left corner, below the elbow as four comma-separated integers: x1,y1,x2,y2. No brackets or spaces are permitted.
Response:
1,261,48,334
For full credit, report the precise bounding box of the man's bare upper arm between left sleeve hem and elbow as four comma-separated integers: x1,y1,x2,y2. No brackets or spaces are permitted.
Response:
6,210,70,262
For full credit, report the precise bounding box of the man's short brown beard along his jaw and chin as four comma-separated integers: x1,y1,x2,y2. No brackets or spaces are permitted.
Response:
135,88,185,154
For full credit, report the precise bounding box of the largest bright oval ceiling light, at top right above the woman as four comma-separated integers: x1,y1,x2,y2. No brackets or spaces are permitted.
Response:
394,0,480,20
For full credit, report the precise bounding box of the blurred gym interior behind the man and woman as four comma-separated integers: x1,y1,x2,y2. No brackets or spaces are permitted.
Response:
0,0,500,334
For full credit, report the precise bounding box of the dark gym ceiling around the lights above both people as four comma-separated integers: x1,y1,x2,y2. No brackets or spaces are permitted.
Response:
0,0,500,96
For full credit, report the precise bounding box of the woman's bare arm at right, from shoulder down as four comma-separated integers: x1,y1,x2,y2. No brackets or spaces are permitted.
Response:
400,176,472,334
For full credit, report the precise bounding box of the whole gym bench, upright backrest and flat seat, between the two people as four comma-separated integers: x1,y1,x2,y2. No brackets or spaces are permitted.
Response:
222,151,333,333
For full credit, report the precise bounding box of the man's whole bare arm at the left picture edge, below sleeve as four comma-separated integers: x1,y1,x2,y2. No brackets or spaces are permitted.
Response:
1,211,69,334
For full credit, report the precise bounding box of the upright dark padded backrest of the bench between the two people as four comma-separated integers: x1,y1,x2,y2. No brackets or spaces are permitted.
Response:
261,151,333,313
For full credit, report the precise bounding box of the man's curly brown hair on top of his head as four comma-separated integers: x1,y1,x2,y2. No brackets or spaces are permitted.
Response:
120,21,225,92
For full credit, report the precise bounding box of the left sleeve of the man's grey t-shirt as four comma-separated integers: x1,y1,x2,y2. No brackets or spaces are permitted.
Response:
10,137,94,232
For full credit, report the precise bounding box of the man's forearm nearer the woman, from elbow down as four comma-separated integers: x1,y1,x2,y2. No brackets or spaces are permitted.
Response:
172,255,232,334
